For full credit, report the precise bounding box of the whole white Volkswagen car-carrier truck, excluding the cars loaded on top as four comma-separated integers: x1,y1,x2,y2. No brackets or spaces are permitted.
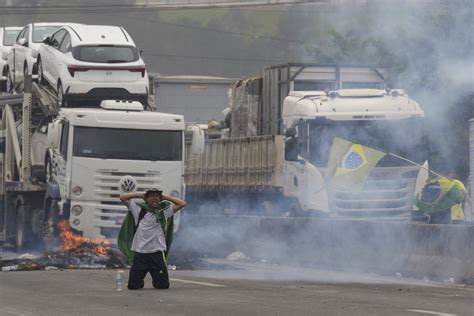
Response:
0,78,185,248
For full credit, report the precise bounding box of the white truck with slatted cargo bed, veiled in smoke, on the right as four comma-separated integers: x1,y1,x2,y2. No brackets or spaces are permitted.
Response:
186,64,428,219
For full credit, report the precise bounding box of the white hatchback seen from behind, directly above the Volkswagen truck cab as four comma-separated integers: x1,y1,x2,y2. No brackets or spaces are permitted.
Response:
38,25,148,106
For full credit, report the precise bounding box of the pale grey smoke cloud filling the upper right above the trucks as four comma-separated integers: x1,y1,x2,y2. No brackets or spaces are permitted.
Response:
290,0,474,180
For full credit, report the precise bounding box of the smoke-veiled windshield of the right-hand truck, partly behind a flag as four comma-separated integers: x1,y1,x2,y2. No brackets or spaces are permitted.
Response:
299,118,426,168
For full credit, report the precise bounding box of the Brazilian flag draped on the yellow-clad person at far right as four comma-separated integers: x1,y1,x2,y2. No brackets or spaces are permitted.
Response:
414,177,464,214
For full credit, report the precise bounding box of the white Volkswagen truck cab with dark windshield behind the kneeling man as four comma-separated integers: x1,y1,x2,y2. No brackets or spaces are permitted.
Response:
45,100,185,243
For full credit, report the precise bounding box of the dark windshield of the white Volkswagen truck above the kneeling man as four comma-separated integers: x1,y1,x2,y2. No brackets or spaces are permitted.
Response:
73,126,182,161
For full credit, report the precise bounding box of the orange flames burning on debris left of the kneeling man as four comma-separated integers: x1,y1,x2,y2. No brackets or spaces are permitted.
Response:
58,220,110,256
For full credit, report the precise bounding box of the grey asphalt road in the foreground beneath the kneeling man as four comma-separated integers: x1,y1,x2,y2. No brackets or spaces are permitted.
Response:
0,259,474,316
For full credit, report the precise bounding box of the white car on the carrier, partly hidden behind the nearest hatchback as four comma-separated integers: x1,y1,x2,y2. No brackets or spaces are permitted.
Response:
6,22,77,91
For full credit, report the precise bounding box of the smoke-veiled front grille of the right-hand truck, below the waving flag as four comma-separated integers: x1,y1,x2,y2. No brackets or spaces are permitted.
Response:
329,166,419,216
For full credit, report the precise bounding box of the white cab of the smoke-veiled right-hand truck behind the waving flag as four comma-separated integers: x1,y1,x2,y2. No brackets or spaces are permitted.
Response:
282,89,428,216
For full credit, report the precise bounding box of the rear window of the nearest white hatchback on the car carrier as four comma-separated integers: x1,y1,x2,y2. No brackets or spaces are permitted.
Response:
73,45,139,64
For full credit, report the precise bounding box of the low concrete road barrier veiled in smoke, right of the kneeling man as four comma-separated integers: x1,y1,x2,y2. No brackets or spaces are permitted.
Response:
176,213,474,284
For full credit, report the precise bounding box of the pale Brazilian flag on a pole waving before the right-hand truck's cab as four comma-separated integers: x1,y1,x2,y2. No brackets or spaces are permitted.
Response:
325,137,386,191
